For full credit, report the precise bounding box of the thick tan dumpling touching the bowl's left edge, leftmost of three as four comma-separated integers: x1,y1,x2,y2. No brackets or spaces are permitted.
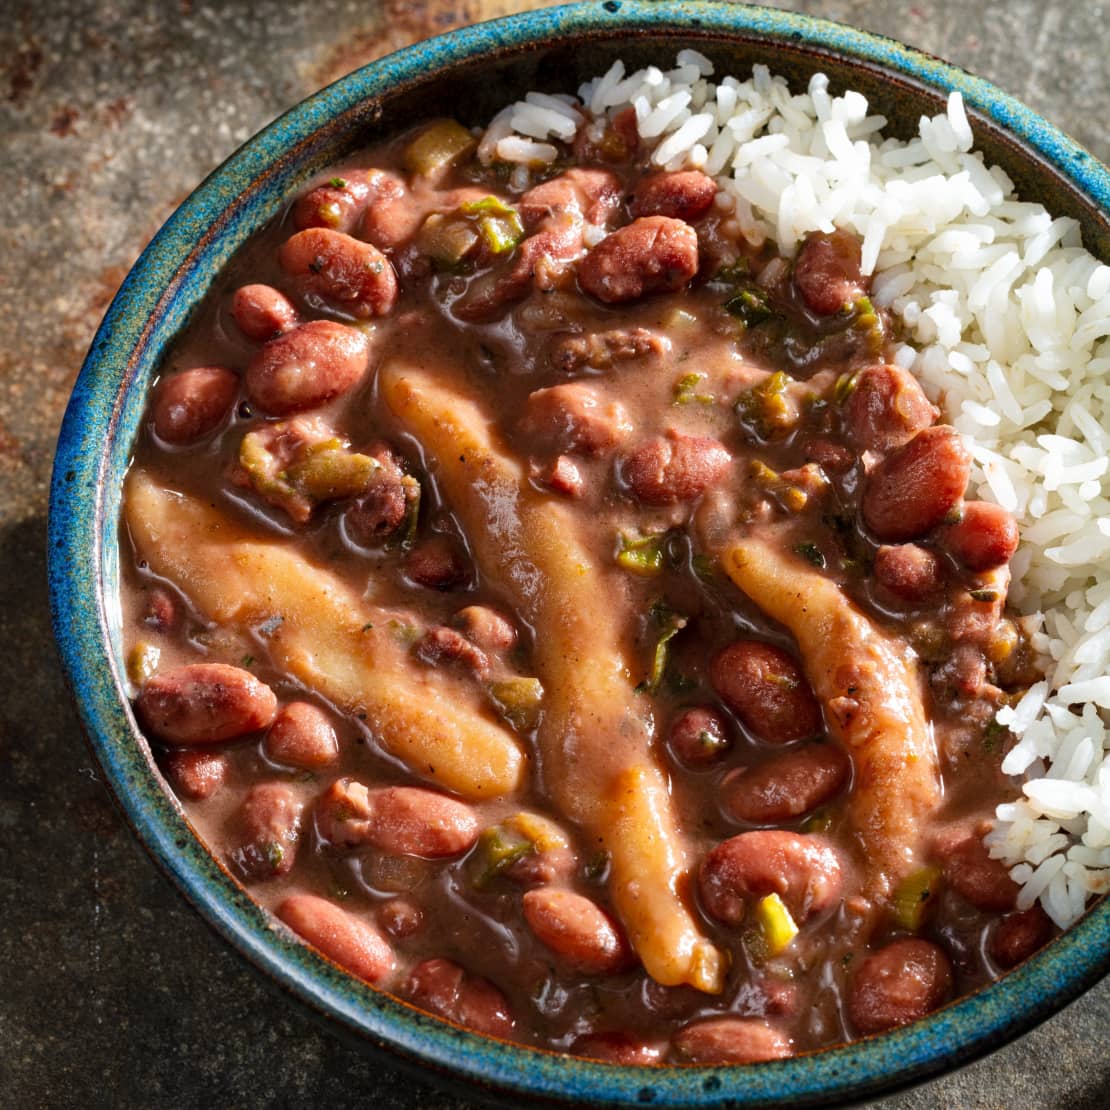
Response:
124,471,525,799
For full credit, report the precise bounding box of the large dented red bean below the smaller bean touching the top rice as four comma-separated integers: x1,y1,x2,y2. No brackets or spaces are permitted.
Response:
578,215,698,304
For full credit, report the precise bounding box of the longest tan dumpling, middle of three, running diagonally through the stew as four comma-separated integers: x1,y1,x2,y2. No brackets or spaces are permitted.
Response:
380,362,726,992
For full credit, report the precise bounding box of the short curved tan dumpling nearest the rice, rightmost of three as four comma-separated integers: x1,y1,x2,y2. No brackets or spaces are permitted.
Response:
724,537,940,899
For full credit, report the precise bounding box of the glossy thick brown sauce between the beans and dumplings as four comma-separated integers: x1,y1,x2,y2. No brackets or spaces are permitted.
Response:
121,117,1047,1051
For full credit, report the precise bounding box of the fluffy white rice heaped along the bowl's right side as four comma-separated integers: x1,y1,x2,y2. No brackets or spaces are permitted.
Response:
480,50,1110,927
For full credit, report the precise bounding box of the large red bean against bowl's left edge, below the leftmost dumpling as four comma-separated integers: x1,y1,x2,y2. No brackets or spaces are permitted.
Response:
135,663,278,744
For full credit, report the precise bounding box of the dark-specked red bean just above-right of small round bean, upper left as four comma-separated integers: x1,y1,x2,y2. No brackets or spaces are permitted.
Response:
278,228,397,317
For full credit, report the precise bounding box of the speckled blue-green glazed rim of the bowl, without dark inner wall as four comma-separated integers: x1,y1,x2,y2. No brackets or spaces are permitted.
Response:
49,0,1110,1107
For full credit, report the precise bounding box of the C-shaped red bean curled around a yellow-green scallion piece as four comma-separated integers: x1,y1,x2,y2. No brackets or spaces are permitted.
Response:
698,829,841,925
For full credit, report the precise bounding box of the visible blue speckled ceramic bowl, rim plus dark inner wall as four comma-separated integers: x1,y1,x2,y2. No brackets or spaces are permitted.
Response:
50,0,1110,1108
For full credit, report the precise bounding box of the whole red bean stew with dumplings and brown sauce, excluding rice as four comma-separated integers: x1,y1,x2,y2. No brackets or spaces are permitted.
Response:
120,114,1055,1066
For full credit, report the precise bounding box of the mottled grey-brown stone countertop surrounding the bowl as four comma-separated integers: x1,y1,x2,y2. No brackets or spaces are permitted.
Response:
0,0,1110,1110
